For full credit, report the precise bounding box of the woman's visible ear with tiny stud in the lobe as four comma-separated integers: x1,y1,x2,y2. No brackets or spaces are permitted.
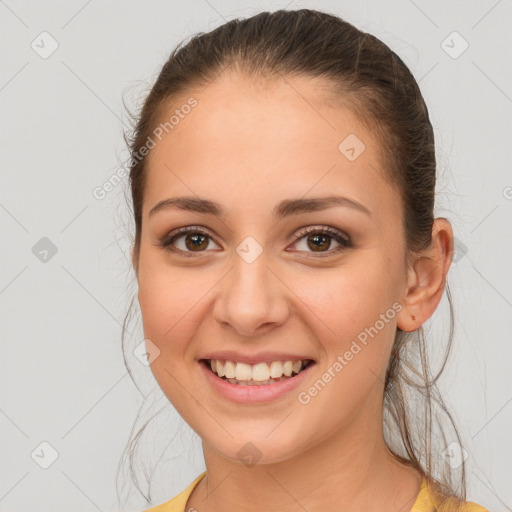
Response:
397,218,454,331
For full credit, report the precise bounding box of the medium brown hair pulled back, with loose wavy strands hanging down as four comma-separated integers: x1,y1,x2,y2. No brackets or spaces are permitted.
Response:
117,9,466,509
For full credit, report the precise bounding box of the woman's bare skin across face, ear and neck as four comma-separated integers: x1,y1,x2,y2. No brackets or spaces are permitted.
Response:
132,73,453,512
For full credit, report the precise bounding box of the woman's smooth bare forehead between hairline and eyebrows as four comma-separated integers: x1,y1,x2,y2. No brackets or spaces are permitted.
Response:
143,74,400,224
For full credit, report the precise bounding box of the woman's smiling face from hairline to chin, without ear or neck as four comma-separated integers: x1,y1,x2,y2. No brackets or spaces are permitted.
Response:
134,75,407,463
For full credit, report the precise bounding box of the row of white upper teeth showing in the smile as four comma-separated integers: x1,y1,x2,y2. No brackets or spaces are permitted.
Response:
205,359,309,382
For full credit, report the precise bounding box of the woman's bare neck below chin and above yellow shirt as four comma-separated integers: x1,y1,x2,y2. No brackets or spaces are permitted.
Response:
186,400,421,512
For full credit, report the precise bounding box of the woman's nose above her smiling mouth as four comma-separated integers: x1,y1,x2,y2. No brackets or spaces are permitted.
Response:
213,254,290,337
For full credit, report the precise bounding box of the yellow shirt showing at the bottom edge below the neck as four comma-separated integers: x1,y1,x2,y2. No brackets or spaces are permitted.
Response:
144,471,489,512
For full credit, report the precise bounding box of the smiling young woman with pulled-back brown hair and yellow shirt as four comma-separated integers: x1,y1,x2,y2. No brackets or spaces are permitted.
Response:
119,9,485,512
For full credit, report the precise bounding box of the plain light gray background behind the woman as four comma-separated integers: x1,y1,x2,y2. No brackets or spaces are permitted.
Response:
0,0,512,512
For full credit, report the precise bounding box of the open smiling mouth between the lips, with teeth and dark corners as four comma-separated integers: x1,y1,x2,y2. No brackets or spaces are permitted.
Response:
199,359,316,386
